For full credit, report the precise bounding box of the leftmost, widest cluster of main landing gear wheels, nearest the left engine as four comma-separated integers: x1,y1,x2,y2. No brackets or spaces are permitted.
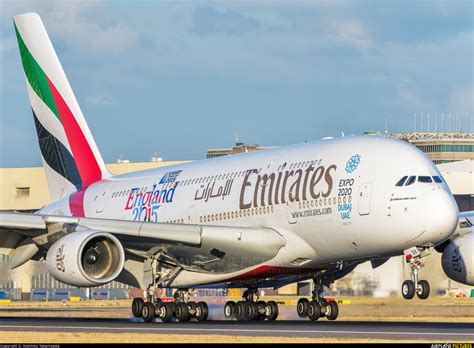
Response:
132,289,209,323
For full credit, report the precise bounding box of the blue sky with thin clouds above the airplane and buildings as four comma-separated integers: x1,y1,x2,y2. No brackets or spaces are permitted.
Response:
0,0,474,167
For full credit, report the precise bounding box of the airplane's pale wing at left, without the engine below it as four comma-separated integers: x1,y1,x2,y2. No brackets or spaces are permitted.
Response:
0,212,286,272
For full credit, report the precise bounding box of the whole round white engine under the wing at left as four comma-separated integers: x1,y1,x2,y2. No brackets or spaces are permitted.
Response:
46,230,125,287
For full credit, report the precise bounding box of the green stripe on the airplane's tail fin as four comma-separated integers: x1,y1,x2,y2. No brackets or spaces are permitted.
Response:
15,24,61,122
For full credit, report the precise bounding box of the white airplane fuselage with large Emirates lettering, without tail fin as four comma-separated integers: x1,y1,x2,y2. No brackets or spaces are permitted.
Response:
41,136,458,285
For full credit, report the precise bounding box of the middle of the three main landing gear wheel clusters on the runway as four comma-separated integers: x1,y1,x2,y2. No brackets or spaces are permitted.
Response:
224,288,278,321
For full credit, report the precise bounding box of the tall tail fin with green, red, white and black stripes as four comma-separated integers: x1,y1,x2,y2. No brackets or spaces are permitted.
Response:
13,13,110,201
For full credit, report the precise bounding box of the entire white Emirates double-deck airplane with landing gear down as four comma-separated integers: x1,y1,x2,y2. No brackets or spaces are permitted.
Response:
0,13,474,321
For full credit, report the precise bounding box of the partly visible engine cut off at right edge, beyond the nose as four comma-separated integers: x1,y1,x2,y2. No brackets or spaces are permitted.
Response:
441,232,474,285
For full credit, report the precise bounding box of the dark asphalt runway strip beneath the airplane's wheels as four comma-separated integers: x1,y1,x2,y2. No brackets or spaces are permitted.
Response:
0,316,474,342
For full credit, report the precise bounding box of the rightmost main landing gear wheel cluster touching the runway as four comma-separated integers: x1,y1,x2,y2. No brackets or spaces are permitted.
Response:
296,279,339,321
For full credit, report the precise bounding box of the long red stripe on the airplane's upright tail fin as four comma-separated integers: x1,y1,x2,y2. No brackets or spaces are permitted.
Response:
46,77,102,187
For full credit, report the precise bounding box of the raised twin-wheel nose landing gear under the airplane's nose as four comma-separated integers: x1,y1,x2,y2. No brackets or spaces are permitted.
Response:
402,247,433,300
